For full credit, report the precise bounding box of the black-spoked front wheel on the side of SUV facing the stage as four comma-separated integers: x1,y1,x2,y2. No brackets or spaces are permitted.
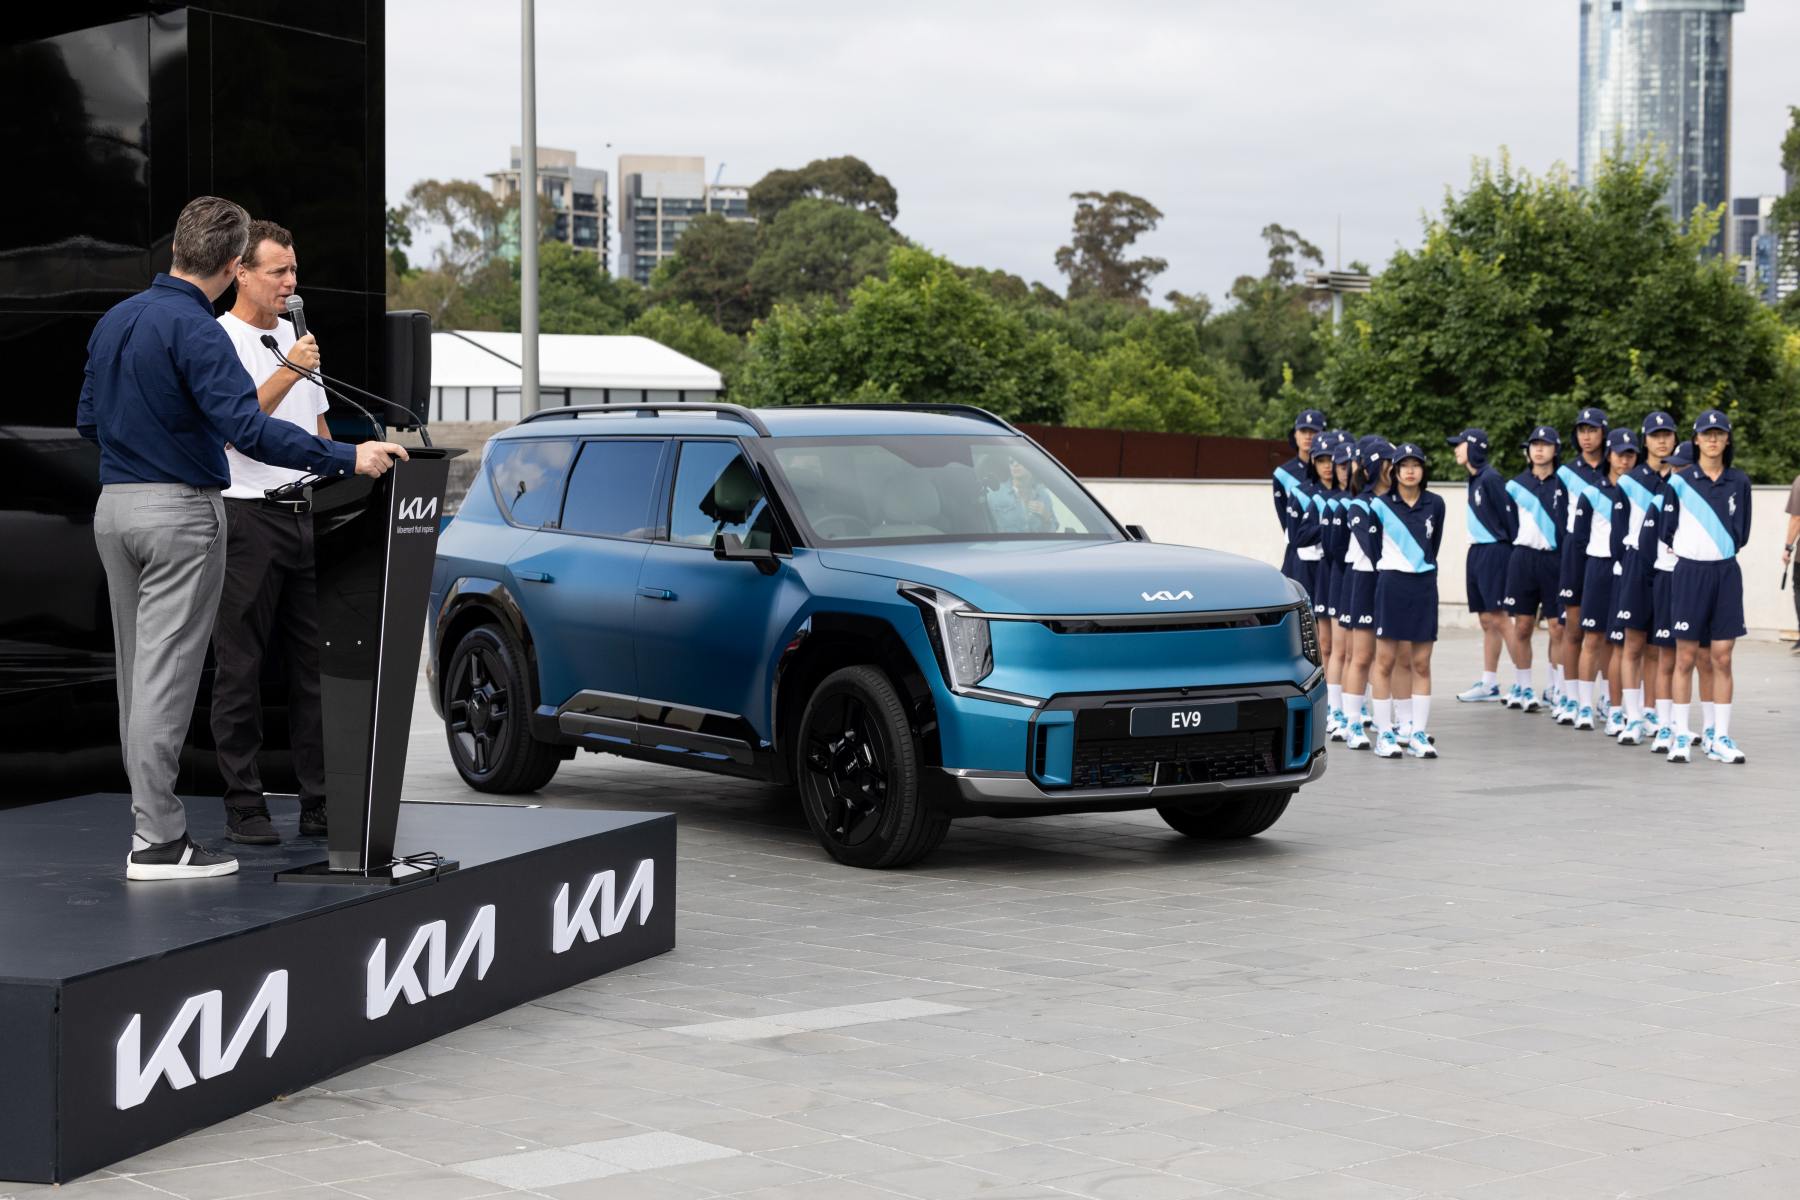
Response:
794,666,950,869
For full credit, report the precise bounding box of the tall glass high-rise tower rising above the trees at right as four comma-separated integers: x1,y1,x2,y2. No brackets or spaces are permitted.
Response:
1577,0,1744,248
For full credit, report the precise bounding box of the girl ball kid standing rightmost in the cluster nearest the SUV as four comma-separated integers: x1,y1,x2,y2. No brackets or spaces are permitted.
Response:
1370,443,1444,757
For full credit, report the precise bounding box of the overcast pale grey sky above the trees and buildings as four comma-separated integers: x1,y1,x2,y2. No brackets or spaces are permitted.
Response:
387,0,1800,300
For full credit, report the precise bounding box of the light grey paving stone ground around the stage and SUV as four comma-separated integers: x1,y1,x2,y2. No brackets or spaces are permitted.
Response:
14,635,1800,1200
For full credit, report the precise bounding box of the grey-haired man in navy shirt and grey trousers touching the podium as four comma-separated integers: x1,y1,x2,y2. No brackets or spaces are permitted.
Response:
76,196,407,880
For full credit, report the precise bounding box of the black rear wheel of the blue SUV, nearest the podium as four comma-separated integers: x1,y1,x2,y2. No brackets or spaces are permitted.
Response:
443,624,563,795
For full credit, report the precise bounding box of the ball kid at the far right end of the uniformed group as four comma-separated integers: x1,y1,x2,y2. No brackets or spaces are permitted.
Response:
1669,408,1750,763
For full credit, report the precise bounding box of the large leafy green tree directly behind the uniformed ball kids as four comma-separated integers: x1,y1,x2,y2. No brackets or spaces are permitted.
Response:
1321,157,1800,477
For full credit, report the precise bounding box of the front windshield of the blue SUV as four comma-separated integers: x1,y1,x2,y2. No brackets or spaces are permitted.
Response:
772,435,1120,545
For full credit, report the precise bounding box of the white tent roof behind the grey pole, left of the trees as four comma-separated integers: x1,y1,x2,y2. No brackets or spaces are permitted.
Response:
432,329,724,392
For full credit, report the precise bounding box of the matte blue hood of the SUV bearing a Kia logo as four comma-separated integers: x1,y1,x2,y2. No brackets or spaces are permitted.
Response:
819,542,1294,615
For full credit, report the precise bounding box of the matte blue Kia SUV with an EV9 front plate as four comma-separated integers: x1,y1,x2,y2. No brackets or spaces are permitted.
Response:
428,403,1325,867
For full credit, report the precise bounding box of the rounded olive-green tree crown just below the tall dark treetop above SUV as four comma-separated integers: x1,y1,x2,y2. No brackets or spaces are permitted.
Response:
745,200,898,304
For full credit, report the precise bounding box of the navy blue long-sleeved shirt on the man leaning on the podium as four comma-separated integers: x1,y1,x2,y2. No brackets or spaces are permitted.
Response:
76,273,356,488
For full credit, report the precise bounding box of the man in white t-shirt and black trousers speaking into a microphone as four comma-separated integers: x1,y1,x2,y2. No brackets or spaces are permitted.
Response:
212,221,331,846
